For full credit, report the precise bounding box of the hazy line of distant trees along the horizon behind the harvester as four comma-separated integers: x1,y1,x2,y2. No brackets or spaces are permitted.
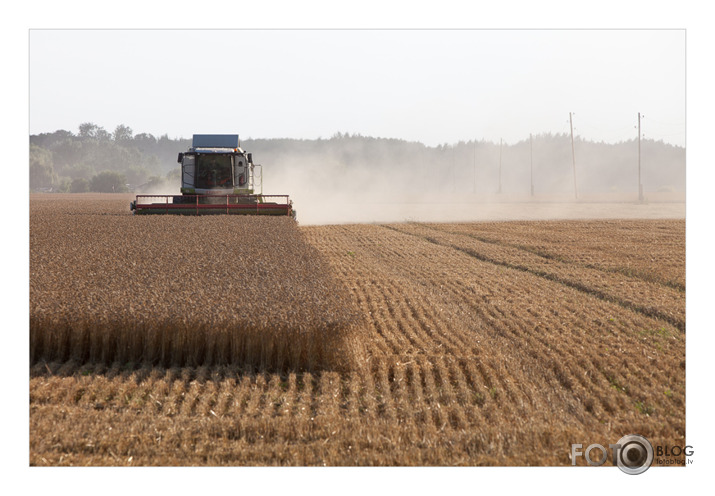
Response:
29,123,685,194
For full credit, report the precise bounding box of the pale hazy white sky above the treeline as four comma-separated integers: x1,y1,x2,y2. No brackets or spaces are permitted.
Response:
30,30,685,145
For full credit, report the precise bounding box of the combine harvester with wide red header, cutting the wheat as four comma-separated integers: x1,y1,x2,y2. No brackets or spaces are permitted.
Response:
129,134,295,218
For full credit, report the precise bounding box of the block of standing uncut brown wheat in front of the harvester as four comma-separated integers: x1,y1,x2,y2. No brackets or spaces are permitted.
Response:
30,198,359,370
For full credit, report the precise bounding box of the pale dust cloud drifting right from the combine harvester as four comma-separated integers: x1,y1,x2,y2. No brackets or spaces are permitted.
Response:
258,137,685,225
